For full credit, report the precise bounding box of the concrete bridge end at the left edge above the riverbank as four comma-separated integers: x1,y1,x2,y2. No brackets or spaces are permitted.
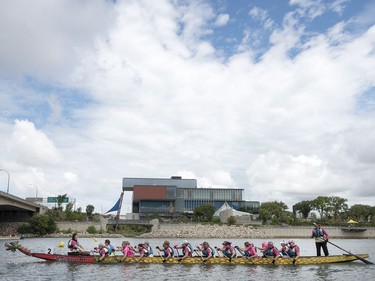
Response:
0,191,48,222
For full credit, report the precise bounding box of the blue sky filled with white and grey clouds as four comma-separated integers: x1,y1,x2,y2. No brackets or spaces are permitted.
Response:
0,0,375,213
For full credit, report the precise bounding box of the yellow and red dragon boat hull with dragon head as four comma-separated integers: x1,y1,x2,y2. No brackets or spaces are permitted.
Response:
5,242,369,265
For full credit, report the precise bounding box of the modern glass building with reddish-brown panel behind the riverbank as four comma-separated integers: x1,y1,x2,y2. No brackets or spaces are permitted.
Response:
122,177,260,217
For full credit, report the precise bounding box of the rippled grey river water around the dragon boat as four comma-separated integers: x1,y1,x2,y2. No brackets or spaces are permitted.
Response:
0,238,375,281
